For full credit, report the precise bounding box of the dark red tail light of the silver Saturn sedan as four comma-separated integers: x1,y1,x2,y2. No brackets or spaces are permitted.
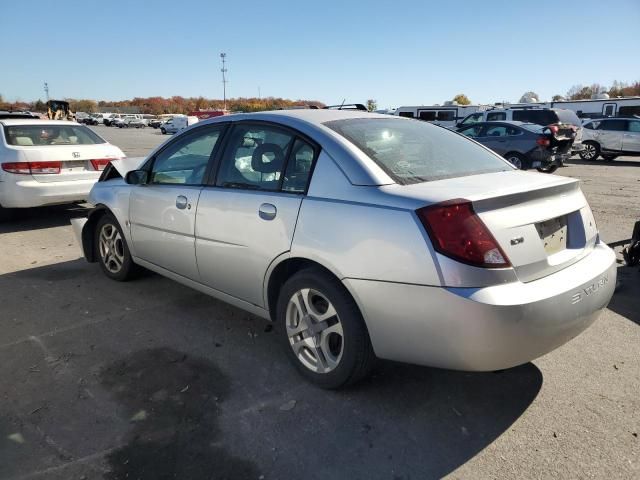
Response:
416,199,511,268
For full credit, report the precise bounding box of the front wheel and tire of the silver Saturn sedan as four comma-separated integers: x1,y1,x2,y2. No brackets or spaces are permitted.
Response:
94,213,139,282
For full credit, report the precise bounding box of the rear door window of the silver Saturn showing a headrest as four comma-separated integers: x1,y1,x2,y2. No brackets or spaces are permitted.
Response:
216,125,296,190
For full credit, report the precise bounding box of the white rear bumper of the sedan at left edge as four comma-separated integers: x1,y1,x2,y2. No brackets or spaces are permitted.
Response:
0,175,98,208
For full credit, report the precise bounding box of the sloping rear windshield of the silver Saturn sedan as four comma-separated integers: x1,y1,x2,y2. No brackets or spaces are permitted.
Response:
325,118,512,185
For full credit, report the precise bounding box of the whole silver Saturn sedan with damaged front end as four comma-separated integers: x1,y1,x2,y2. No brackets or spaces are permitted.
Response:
73,110,616,388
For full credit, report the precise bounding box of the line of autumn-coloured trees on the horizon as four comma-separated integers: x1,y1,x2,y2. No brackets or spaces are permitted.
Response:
0,95,324,115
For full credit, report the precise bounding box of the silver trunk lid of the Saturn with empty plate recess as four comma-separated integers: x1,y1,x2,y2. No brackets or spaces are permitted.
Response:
384,171,597,282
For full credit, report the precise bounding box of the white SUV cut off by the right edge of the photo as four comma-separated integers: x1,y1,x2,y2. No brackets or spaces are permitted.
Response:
580,117,640,160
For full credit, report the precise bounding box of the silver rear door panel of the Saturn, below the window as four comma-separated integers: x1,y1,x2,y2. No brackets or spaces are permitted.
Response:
196,187,302,306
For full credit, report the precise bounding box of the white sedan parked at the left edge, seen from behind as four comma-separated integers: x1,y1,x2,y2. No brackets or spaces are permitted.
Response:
0,119,125,220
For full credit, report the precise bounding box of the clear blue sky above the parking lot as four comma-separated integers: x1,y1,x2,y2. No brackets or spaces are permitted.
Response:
0,0,640,108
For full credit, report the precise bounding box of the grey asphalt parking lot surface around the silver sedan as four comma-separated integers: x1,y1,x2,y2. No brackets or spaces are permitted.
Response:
0,127,640,480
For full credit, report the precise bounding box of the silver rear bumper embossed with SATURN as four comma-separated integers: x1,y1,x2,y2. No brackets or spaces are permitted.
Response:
345,244,616,371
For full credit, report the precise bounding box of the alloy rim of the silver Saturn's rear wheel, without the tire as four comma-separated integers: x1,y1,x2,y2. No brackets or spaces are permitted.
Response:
285,288,344,373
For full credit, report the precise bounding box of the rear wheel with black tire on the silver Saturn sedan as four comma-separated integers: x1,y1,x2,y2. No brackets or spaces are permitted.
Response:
276,268,375,389
